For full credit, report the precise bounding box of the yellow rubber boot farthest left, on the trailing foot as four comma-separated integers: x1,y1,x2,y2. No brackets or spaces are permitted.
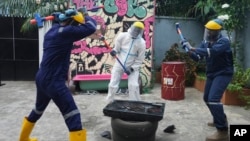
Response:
19,117,37,141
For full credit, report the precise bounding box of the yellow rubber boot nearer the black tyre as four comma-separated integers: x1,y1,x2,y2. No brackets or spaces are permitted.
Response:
69,129,87,141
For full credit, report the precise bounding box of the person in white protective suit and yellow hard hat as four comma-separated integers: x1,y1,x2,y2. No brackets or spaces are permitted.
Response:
106,22,146,102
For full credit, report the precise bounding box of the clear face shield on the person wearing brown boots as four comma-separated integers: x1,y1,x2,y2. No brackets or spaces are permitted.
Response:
204,28,221,42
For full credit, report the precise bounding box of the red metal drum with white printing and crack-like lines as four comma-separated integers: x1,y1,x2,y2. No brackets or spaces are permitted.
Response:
161,61,185,100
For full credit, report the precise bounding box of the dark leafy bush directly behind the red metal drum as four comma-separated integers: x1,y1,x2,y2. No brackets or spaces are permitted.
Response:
162,43,197,86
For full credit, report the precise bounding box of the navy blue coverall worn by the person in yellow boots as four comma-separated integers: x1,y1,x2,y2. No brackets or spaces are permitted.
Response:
28,16,96,131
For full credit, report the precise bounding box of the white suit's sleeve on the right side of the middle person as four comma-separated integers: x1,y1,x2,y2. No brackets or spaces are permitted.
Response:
131,39,146,70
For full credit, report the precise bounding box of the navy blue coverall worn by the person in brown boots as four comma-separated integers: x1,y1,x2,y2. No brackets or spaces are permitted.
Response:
191,35,234,130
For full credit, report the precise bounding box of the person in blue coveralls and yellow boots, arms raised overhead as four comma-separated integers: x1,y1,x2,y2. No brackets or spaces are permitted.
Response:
19,9,96,141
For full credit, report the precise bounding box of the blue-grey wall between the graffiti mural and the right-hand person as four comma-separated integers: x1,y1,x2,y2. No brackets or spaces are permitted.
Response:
153,16,204,70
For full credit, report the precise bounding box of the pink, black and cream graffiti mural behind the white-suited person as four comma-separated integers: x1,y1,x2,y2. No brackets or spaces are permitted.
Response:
70,0,154,87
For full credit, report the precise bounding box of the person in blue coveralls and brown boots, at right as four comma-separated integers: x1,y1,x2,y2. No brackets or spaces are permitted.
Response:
183,19,234,141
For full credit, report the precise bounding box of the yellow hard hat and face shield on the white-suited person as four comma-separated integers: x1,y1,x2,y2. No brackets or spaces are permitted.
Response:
128,22,144,39
